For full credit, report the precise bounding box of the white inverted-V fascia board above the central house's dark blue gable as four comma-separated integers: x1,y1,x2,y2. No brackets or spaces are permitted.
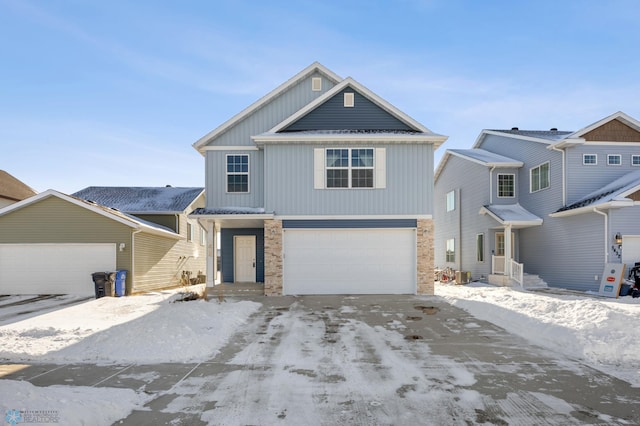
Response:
269,77,447,136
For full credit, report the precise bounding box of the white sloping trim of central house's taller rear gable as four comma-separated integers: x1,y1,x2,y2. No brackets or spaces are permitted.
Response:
193,62,341,151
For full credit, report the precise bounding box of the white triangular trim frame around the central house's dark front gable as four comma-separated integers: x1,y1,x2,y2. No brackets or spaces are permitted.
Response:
252,77,447,148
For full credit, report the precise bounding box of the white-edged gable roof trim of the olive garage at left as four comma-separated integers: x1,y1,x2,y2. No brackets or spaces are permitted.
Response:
0,189,183,239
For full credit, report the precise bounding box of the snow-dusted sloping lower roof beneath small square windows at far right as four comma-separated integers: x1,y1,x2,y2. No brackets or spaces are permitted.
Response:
550,170,640,217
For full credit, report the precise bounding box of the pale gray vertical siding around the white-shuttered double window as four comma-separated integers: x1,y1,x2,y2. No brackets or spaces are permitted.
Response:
265,142,433,215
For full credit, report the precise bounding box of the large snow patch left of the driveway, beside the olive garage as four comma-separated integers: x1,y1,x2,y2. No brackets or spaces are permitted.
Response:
0,291,260,364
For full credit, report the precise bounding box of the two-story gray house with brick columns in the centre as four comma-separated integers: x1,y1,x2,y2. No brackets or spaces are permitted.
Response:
191,63,446,295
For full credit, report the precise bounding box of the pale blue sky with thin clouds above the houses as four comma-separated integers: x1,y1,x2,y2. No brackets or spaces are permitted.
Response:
0,0,640,193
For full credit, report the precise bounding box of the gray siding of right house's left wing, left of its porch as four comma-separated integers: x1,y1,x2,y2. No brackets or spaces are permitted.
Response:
434,155,498,279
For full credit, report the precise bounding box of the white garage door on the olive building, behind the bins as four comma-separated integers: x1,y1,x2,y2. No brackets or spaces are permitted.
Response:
0,244,116,295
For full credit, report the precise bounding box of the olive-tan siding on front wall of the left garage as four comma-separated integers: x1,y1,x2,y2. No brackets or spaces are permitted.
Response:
0,197,132,272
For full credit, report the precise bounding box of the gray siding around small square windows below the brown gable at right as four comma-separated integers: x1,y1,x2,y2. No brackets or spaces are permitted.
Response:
567,145,640,204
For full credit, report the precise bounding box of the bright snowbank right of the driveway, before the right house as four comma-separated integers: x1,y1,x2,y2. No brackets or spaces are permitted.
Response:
435,283,640,387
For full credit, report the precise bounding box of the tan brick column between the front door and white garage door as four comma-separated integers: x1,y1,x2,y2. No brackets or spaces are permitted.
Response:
264,219,282,296
